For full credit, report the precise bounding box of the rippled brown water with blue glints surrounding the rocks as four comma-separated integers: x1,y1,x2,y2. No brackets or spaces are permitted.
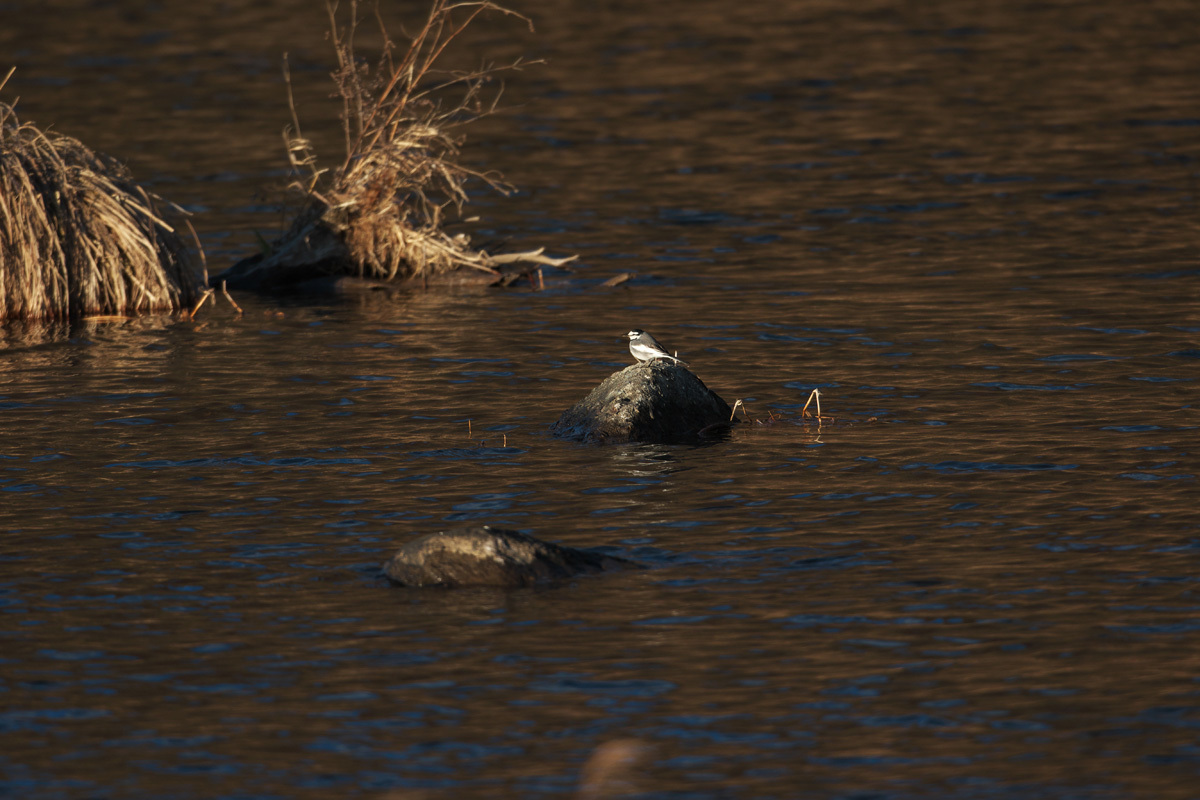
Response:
0,0,1200,799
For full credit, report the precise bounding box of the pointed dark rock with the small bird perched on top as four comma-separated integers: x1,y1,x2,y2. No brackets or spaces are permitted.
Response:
551,360,732,444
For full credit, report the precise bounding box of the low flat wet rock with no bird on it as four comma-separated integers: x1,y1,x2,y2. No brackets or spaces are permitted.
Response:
383,525,637,589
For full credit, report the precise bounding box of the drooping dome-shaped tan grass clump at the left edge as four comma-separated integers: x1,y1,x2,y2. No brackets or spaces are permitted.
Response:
0,82,198,320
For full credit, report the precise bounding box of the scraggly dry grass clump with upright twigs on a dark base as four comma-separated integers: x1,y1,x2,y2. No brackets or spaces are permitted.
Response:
220,0,571,288
